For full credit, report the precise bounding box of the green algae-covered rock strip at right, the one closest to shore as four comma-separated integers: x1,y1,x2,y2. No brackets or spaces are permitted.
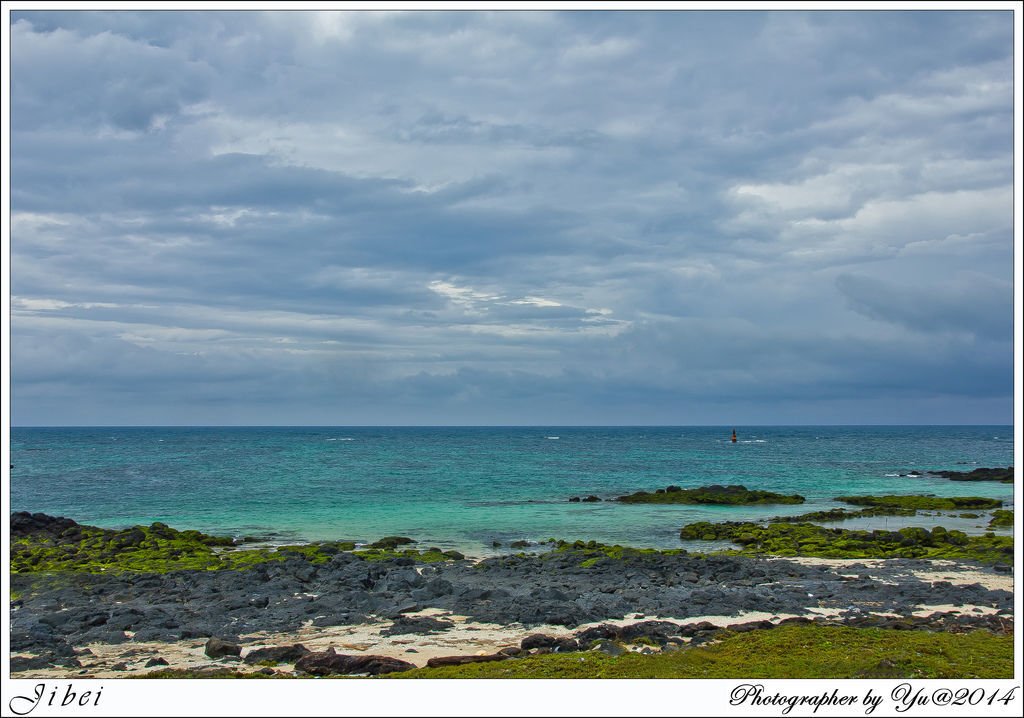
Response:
679,521,1014,563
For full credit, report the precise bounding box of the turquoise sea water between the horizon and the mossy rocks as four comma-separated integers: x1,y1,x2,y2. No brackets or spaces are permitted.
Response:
10,426,1014,554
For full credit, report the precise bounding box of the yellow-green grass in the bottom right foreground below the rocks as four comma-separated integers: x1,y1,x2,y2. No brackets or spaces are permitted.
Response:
387,626,1014,679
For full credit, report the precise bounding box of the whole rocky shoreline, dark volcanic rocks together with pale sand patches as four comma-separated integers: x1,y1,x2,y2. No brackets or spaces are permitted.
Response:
10,514,1013,677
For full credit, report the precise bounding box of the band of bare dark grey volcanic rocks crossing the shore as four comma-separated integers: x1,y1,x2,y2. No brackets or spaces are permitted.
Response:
9,515,1013,670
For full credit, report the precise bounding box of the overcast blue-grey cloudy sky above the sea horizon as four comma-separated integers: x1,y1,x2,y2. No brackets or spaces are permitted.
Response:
10,11,1014,425
